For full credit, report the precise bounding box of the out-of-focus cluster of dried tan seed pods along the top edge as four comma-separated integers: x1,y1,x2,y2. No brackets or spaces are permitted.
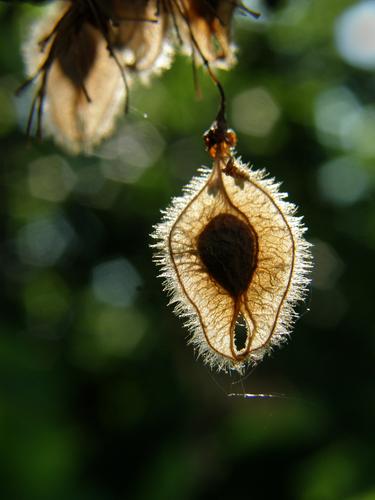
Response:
21,0,258,152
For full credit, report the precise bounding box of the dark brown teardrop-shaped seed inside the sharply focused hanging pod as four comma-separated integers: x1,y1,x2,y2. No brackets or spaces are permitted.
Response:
197,214,258,299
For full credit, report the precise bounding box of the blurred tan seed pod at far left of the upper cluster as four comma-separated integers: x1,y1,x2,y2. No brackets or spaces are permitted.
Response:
24,1,127,152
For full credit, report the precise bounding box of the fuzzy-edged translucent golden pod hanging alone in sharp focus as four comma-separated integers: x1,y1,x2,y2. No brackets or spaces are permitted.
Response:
153,158,311,372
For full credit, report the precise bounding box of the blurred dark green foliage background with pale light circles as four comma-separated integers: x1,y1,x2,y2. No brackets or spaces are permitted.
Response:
0,0,375,500
